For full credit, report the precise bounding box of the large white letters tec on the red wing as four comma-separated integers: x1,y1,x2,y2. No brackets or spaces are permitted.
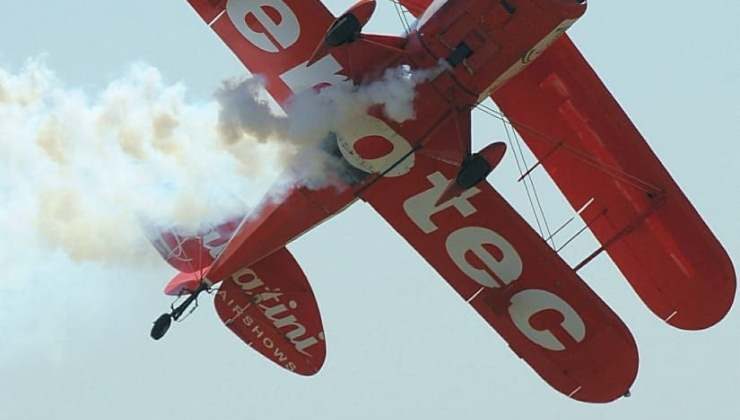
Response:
403,172,586,351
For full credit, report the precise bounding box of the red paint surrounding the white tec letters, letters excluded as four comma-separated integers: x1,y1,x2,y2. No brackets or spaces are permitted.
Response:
362,135,638,402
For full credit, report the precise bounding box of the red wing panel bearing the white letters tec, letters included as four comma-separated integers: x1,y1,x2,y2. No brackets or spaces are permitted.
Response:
361,126,638,402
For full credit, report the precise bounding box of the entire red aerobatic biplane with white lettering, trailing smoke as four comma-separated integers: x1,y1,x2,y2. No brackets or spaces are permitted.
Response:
152,0,735,402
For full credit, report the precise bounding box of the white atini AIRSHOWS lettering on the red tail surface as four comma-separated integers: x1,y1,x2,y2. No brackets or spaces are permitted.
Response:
217,268,324,370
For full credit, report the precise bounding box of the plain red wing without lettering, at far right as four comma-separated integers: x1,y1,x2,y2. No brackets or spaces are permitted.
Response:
493,36,735,329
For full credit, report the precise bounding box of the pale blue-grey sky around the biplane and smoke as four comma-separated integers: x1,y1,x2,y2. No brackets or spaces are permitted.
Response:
0,0,740,420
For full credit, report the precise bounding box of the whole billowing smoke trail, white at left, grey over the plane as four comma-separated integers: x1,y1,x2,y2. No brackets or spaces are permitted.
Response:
0,60,441,270
